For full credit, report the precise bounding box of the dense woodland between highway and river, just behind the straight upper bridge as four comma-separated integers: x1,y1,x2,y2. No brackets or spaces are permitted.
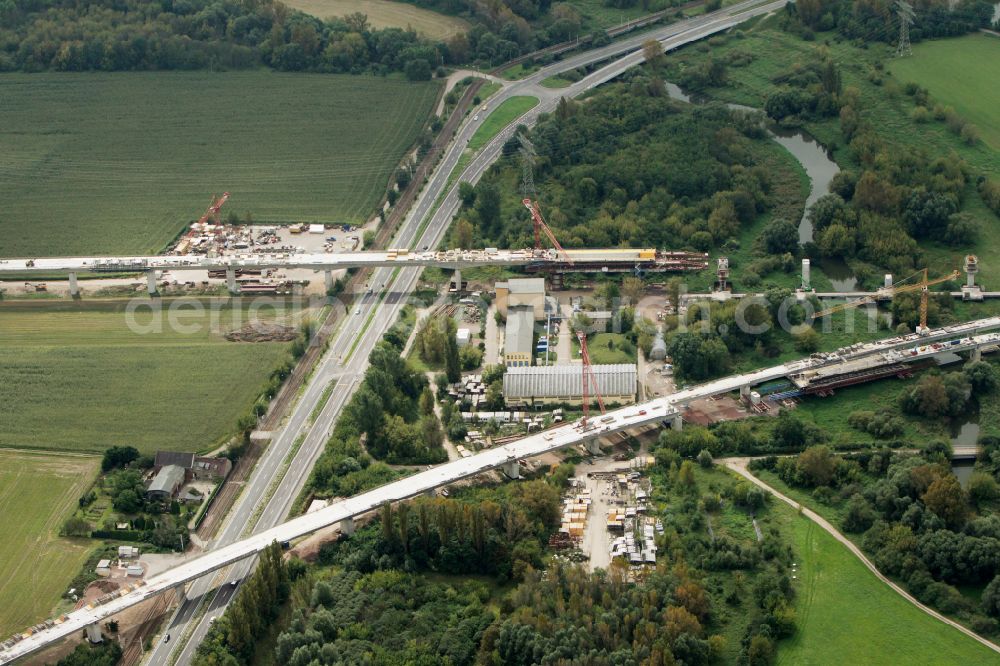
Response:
452,78,788,250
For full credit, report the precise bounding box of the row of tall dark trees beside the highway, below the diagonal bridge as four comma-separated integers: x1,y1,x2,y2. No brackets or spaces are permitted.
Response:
194,541,292,666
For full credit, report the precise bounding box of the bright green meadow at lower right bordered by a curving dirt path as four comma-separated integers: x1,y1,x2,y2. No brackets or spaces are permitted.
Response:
776,507,996,666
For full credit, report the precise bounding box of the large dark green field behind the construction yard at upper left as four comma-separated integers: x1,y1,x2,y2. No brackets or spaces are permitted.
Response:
0,71,440,256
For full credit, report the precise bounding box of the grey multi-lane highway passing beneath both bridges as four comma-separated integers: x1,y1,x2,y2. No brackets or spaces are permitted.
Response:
147,0,784,666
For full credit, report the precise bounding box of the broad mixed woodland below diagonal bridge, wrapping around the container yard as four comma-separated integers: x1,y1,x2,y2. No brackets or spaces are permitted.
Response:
198,438,796,666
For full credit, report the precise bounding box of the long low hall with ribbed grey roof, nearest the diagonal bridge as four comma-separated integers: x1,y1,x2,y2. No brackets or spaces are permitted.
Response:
503,363,637,406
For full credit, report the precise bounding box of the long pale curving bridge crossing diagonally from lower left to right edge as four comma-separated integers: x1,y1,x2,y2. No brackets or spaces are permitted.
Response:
0,317,1000,664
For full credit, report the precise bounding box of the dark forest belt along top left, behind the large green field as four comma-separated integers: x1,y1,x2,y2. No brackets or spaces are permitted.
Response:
0,0,448,80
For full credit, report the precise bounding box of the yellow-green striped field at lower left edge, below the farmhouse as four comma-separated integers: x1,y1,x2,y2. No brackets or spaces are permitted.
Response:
0,446,101,638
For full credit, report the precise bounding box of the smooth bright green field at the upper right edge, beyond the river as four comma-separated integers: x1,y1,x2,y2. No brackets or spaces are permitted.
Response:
889,34,1000,150
